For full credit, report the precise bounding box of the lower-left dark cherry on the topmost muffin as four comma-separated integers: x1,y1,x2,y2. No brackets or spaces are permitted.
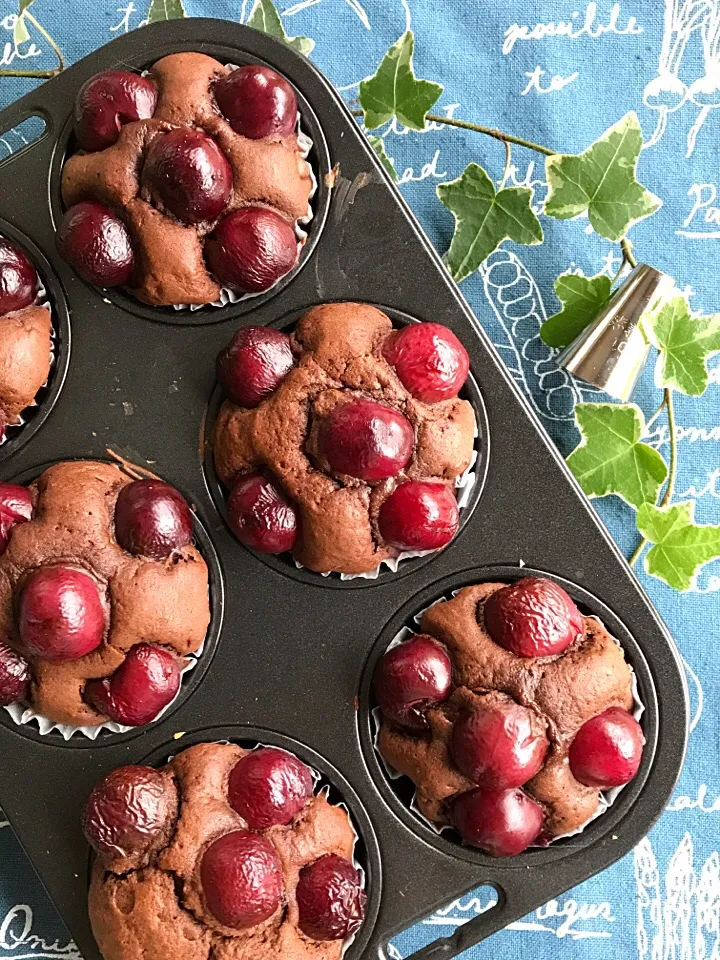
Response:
56,200,135,287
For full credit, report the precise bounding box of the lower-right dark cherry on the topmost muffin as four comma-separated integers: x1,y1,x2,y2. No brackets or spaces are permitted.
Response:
205,207,298,293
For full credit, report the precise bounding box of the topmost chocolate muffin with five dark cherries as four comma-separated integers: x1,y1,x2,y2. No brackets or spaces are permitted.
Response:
58,53,313,305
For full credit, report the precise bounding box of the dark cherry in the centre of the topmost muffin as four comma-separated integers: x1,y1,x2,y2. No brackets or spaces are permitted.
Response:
142,127,233,223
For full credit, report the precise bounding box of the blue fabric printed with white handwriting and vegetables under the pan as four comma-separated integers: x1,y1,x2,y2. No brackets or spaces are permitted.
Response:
0,0,720,960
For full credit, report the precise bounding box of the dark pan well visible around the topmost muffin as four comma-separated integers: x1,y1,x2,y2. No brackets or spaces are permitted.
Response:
49,51,332,326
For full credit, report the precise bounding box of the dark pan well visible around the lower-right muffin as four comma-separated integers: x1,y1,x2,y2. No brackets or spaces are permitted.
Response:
362,568,645,856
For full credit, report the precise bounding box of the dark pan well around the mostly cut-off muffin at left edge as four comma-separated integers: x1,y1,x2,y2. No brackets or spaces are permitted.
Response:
0,219,70,464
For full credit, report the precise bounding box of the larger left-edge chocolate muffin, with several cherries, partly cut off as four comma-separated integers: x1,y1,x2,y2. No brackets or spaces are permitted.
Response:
0,461,210,727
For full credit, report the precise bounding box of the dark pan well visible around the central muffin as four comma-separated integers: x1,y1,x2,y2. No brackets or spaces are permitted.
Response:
200,303,490,587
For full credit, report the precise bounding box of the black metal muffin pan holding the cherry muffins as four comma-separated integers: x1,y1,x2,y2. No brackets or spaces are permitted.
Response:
0,19,688,960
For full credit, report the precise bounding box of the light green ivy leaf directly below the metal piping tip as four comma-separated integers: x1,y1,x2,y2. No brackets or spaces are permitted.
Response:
567,403,667,507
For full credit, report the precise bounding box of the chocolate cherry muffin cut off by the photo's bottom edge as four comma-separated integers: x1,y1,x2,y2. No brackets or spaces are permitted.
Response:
83,743,365,960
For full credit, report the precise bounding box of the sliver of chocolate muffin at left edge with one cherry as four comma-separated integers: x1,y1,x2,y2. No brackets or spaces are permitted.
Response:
0,236,52,441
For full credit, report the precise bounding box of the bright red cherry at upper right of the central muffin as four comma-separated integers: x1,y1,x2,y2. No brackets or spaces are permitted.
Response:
383,323,470,403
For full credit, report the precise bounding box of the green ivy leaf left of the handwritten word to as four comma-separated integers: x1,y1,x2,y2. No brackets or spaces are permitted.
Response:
360,30,443,130
